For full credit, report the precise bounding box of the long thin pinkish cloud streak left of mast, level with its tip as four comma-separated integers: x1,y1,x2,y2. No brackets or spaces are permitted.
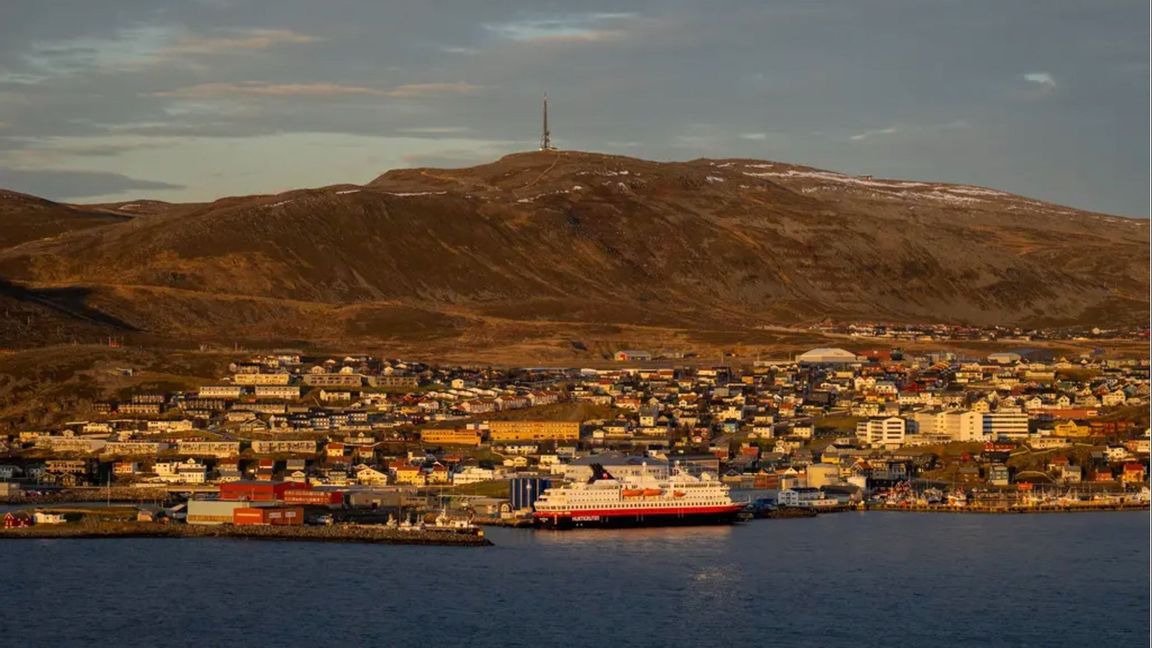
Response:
152,81,480,99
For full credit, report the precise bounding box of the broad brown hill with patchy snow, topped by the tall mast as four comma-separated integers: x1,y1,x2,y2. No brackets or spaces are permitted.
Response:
0,152,1149,346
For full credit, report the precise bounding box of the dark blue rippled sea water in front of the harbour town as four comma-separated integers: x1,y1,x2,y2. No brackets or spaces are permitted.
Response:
0,513,1149,648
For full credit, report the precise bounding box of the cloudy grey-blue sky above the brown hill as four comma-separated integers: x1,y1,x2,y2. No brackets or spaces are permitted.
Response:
0,0,1149,218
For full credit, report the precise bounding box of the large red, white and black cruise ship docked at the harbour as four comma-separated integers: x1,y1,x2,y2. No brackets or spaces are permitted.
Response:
532,465,744,528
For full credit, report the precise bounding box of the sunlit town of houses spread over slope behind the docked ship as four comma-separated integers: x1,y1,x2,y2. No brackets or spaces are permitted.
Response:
0,348,1149,523
